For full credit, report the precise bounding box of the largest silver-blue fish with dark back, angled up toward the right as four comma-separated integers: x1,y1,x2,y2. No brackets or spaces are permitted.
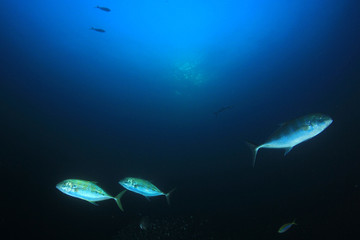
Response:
247,113,333,167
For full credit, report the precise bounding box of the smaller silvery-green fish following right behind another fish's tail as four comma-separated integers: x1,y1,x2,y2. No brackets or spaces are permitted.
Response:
119,177,175,205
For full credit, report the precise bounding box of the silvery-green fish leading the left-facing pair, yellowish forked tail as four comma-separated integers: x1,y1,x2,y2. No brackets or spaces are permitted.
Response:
56,179,126,211
